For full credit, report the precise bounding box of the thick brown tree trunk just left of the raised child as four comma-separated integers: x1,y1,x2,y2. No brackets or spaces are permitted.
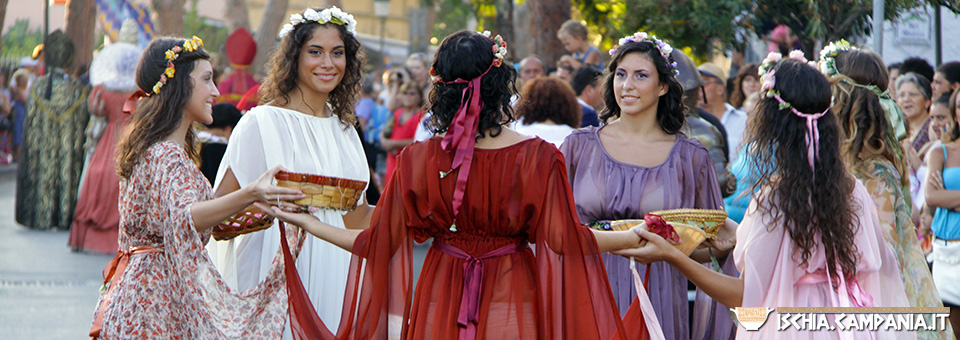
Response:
527,0,571,67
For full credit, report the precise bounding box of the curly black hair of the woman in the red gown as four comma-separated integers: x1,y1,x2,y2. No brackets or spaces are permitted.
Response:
427,30,517,139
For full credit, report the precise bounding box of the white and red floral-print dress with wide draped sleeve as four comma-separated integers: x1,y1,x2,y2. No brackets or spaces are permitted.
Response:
95,141,304,339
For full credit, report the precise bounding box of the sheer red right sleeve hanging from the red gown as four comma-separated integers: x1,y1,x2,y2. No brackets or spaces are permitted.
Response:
526,149,647,339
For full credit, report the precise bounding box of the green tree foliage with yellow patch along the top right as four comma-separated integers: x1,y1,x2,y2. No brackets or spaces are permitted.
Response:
573,0,960,57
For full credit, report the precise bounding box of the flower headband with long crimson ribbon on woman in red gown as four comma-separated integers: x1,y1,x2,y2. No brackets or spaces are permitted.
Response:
430,31,507,232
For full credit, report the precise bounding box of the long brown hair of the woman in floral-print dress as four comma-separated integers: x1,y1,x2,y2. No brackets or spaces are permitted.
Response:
116,38,210,179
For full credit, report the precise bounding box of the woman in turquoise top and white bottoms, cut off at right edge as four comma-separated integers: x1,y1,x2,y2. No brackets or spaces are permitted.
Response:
925,91,960,334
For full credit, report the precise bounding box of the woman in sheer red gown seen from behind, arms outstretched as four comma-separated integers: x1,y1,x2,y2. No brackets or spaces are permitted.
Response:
264,31,647,339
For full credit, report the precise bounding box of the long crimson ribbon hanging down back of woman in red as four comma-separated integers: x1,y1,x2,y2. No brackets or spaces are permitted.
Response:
439,63,493,227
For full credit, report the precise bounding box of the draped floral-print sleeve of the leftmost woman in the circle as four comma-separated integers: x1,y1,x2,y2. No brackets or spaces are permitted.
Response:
157,155,304,339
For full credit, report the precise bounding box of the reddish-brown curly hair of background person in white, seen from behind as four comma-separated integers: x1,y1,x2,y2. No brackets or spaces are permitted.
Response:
517,77,583,129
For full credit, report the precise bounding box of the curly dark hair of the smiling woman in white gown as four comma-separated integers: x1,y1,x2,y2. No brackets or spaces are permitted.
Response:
257,8,366,126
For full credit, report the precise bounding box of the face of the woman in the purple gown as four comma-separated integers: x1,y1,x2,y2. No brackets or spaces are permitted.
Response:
613,52,667,116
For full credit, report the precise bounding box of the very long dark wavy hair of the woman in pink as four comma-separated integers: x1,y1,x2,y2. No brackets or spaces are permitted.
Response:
747,59,860,283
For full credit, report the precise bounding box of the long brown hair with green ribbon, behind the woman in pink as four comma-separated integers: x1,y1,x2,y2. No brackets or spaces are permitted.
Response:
830,49,910,185
